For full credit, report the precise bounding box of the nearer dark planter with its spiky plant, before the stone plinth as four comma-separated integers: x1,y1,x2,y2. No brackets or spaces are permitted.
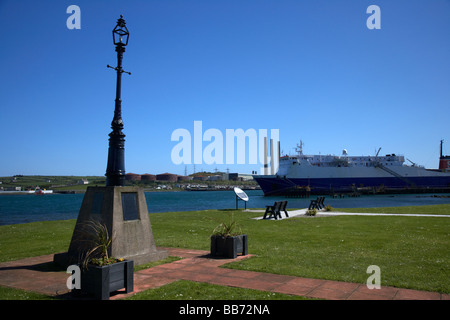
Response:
74,220,134,300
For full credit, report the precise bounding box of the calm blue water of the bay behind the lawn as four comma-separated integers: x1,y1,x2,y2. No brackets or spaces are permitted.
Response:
0,190,450,225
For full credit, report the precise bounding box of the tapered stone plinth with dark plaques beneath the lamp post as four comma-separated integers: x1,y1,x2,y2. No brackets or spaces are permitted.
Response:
54,187,168,265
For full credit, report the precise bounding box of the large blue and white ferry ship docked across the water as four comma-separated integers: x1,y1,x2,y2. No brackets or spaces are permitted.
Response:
253,140,450,196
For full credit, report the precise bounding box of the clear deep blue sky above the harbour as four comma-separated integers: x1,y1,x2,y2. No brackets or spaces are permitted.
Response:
0,0,450,176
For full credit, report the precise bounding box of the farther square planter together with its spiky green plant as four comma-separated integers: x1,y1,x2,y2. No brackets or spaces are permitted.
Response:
211,214,248,259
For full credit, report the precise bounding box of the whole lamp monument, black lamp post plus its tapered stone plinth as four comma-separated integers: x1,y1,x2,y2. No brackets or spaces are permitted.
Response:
53,16,169,272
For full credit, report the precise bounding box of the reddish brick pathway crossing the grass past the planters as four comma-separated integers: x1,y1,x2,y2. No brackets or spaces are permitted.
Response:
0,248,450,300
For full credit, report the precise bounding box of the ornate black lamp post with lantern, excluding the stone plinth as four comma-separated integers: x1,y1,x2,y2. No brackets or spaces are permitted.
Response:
105,15,131,186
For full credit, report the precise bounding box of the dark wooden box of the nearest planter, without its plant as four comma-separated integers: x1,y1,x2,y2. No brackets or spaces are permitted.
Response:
80,260,134,300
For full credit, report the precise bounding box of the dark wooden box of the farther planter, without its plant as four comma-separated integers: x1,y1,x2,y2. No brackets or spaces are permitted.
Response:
211,234,248,259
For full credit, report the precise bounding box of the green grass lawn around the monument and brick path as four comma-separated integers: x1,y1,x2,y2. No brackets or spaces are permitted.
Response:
0,205,450,299
